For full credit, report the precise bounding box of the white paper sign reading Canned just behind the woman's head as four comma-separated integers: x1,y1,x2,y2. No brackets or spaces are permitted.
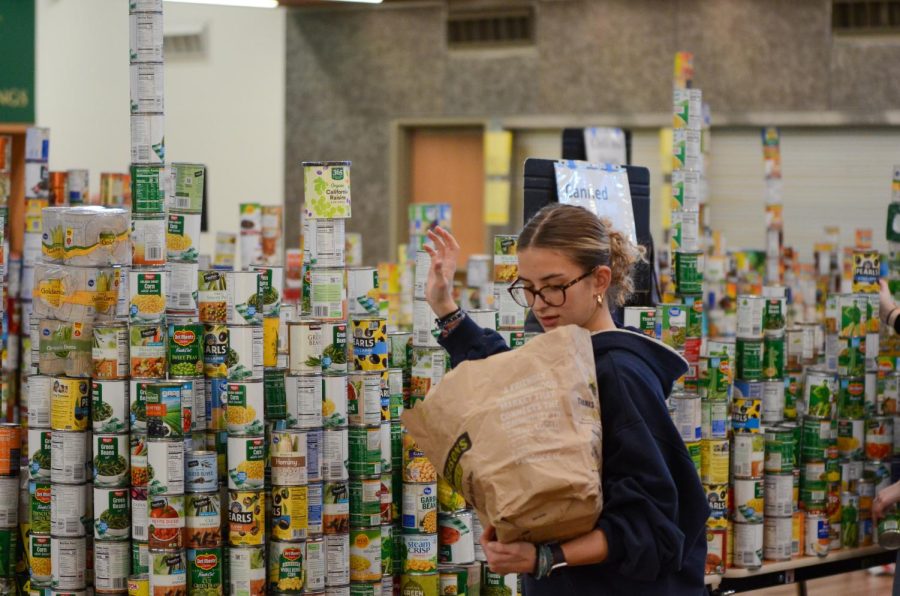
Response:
554,160,637,243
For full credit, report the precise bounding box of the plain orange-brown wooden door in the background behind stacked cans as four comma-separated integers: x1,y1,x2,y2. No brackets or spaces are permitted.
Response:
409,127,488,270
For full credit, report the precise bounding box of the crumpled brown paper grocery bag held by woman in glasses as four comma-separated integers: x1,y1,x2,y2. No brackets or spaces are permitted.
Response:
403,325,603,543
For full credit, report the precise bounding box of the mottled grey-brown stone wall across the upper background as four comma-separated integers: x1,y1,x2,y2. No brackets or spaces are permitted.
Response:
285,0,900,262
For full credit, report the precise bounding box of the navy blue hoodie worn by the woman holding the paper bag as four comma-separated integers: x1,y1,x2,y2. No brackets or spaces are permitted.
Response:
440,317,709,596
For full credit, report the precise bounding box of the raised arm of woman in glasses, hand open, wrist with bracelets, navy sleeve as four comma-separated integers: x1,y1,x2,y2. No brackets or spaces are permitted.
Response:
425,226,509,367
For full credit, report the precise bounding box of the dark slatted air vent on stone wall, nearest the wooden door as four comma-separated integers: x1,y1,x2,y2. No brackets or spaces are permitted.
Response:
447,6,534,49
